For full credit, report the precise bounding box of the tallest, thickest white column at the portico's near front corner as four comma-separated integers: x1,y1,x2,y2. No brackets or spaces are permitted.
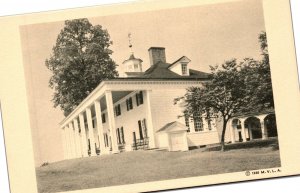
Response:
105,91,119,153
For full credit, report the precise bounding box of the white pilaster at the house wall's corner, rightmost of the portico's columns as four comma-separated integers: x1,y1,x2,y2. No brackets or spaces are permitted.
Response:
146,90,156,148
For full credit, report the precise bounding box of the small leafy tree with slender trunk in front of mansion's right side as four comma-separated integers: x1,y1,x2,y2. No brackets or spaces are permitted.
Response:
175,59,249,151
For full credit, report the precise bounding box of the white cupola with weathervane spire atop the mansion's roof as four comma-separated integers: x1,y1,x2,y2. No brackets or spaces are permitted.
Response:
123,33,143,76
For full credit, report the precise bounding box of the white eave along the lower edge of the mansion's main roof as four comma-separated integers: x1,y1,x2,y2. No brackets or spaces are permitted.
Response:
59,77,210,125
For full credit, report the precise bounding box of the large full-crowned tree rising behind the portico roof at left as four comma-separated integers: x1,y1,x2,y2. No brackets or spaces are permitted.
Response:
45,19,118,116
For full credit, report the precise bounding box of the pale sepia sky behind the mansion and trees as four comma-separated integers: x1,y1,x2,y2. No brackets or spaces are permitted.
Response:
20,0,265,165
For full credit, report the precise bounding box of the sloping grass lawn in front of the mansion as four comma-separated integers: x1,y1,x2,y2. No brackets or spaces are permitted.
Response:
36,139,280,193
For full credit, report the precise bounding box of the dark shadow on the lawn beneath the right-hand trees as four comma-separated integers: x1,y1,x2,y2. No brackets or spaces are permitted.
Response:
203,138,279,152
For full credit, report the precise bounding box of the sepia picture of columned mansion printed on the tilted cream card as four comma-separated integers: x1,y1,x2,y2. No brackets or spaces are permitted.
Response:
3,0,299,193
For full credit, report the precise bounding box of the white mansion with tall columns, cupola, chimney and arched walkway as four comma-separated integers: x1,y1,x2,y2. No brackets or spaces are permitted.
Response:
60,47,277,159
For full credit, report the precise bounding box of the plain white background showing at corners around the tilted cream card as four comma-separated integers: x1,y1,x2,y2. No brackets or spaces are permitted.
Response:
0,0,300,193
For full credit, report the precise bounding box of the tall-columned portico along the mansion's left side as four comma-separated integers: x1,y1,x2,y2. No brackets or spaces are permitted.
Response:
61,79,199,159
